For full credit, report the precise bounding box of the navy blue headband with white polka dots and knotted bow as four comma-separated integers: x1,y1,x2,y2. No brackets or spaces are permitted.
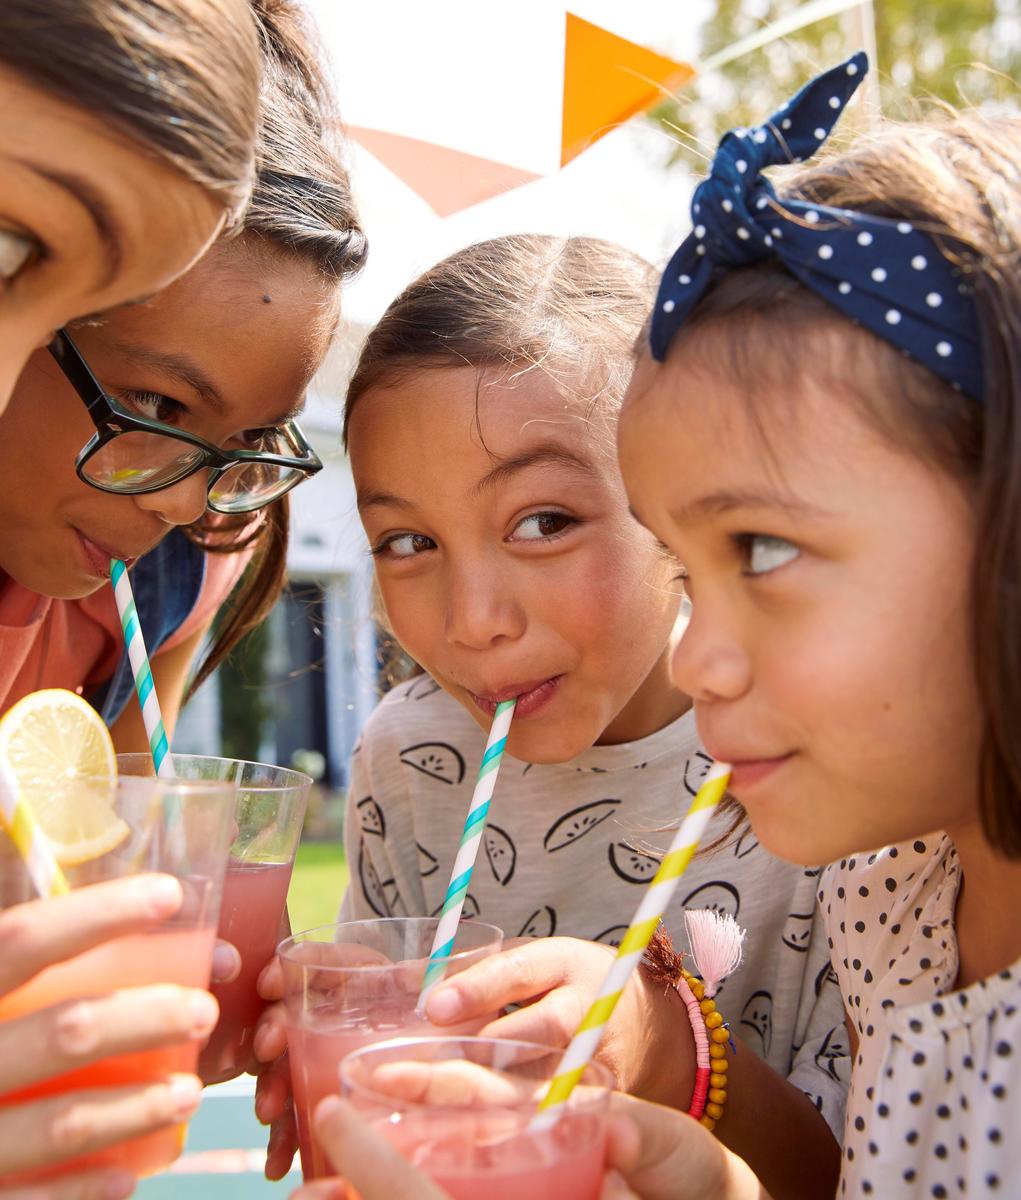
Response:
650,52,983,400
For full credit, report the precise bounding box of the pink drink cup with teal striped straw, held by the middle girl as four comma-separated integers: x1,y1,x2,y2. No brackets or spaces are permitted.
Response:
277,917,503,1181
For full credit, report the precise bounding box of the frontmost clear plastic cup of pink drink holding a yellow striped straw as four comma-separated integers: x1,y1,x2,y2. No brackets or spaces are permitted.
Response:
341,1038,613,1200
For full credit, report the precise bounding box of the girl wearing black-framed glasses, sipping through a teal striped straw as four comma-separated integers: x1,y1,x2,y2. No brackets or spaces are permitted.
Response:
0,4,365,751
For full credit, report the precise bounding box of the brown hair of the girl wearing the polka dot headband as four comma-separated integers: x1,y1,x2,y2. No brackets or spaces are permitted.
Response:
652,114,1021,859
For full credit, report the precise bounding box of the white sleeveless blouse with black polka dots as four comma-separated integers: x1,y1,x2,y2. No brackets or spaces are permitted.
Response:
818,834,1021,1200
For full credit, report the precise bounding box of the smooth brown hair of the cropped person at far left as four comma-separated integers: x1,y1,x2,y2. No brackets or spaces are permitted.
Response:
0,0,260,214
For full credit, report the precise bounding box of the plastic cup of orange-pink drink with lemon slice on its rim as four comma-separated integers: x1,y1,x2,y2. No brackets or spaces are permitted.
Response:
0,776,235,1187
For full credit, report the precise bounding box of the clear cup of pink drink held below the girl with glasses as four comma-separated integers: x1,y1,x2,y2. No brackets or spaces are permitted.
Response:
118,754,312,1084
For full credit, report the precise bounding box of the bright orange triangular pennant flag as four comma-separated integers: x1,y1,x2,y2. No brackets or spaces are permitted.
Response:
560,12,695,167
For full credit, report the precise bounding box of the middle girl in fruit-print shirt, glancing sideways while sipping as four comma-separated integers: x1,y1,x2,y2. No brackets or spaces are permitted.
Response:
323,236,847,1195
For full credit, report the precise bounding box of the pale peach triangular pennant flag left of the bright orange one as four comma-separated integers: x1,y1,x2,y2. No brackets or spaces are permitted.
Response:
347,126,539,217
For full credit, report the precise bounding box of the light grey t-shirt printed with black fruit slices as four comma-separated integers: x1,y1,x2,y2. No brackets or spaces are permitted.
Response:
341,676,849,1138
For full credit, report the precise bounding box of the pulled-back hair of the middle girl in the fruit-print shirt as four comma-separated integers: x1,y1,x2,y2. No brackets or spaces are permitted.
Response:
344,234,655,442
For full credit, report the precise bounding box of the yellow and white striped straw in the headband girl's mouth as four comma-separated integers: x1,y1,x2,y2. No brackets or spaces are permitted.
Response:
529,762,731,1133
